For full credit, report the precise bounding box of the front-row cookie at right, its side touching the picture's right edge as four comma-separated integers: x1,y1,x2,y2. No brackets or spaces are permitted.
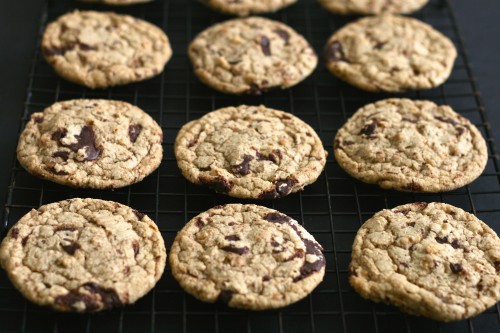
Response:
349,202,500,321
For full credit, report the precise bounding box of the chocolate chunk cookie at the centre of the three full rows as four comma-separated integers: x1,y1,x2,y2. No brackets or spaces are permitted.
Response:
174,105,327,199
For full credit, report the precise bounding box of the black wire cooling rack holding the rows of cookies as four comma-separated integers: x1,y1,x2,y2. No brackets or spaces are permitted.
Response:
0,0,500,333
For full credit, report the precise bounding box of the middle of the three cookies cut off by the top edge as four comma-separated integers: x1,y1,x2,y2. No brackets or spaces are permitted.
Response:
200,0,297,16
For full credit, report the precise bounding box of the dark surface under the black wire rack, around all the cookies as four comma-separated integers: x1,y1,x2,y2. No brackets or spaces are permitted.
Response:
0,0,500,333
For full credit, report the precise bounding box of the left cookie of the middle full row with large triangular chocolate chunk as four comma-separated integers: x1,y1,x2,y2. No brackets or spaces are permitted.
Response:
17,99,163,189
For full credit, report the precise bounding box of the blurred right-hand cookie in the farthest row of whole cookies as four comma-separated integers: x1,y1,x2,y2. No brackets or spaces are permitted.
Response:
324,15,457,92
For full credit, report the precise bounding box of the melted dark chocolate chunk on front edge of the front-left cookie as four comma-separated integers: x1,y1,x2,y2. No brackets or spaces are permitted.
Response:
55,282,123,311
